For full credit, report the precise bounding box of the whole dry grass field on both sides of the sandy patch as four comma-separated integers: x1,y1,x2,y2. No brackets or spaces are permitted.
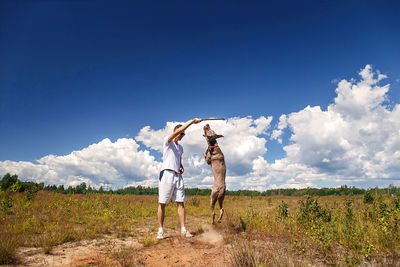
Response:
0,191,400,266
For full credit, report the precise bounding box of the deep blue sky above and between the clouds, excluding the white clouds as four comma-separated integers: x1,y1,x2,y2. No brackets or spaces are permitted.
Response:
0,1,400,189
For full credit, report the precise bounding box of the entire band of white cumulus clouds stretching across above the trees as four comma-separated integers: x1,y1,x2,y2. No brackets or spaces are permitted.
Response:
0,65,400,190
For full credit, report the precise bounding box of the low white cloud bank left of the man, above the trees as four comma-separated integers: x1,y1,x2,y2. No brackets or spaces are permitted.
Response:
0,138,160,186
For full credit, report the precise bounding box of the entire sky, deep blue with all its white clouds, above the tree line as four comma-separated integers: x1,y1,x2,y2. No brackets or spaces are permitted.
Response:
0,1,400,192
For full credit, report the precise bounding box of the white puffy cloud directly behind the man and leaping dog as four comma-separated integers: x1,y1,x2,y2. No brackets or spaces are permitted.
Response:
135,116,272,188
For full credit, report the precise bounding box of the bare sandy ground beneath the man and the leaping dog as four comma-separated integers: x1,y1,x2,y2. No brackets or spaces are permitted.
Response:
14,225,226,267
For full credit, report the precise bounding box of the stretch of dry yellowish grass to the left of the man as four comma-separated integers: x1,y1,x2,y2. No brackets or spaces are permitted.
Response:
0,191,157,263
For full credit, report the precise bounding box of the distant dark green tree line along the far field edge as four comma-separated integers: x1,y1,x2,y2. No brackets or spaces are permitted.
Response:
0,173,400,196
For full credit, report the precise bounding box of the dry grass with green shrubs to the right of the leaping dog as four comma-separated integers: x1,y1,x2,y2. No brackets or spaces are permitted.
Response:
223,196,400,266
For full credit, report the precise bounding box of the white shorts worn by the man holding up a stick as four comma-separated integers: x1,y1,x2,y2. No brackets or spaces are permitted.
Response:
158,170,186,204
